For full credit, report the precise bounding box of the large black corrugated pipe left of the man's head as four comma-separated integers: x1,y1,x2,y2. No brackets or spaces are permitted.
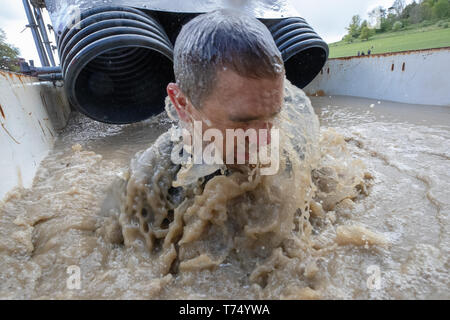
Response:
58,6,173,124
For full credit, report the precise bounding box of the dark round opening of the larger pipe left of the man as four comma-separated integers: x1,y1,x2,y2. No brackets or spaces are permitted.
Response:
75,47,173,124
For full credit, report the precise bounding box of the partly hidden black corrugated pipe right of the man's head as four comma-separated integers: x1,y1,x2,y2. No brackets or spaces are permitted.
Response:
265,17,329,89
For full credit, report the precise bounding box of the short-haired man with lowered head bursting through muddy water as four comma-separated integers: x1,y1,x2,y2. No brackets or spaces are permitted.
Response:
116,10,285,250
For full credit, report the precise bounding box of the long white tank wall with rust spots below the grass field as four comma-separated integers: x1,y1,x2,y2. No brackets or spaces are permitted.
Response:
304,47,450,106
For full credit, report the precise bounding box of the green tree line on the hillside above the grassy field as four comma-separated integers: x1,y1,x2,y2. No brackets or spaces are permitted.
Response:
342,0,450,43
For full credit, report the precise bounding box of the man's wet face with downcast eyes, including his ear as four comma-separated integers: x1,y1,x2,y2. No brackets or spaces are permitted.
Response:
167,69,284,160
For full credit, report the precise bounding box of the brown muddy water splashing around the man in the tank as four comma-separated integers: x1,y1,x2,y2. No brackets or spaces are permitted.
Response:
0,85,450,299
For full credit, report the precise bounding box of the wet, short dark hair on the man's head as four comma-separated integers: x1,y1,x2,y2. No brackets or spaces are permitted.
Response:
174,9,284,108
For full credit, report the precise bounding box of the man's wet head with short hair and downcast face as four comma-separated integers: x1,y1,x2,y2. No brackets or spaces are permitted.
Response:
167,10,284,162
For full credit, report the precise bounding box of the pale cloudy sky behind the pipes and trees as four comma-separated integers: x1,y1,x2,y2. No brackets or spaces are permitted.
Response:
0,0,412,66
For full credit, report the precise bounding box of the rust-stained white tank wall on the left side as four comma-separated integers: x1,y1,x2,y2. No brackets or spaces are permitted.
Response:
0,71,70,200
